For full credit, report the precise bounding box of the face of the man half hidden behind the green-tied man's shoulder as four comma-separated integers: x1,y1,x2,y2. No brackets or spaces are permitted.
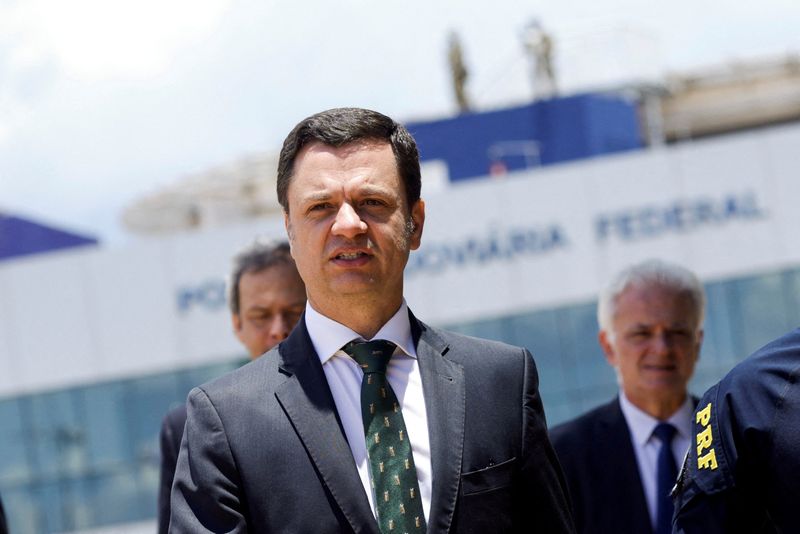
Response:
232,263,306,359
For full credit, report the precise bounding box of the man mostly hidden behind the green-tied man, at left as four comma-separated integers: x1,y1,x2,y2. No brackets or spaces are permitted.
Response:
158,241,306,534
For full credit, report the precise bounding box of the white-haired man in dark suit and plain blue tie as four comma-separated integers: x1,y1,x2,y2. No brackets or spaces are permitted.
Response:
550,260,705,534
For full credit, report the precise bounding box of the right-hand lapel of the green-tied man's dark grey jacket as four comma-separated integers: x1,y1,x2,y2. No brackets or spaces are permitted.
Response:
409,312,465,533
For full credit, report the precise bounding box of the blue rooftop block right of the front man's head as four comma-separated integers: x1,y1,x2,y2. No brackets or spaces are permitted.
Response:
407,94,643,181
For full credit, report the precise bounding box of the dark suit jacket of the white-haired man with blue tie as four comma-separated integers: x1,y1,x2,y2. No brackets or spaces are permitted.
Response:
550,398,653,534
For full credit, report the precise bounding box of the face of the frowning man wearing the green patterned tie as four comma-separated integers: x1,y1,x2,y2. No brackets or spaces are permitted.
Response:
285,142,425,313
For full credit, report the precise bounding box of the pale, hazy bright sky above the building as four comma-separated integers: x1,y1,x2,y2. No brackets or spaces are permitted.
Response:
0,0,800,246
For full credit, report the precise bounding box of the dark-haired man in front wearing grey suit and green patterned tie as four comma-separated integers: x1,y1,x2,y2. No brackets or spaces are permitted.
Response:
170,108,573,534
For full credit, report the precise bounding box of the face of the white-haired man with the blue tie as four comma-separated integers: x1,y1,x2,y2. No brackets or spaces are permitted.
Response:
600,284,703,411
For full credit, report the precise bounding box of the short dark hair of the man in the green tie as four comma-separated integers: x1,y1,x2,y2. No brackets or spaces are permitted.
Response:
278,108,421,213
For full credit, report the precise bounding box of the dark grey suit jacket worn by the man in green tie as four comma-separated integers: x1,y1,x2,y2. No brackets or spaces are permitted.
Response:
170,315,573,534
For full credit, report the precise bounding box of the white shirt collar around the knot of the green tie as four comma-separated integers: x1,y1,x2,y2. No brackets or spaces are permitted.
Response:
305,299,417,364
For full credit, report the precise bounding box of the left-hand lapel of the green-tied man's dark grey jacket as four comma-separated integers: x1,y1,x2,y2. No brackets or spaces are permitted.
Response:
275,319,379,534
